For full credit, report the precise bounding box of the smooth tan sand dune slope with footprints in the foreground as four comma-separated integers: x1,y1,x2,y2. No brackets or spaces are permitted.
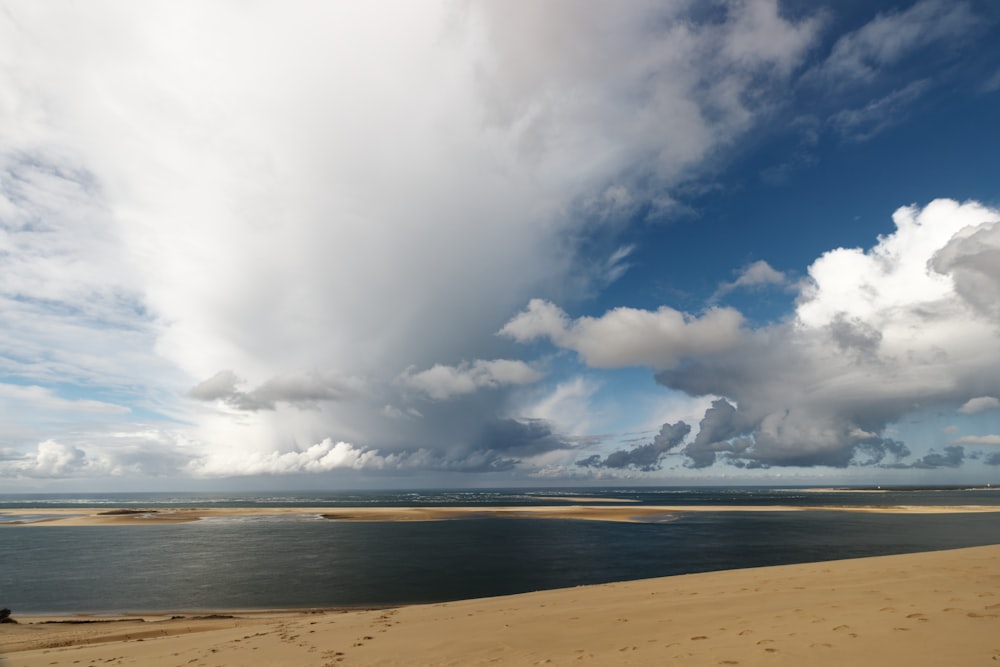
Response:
0,546,1000,667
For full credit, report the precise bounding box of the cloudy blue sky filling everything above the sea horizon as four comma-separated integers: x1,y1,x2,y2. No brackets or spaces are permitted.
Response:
0,0,1000,492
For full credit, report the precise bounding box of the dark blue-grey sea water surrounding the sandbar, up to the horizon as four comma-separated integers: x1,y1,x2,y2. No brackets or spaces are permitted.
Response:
0,488,1000,613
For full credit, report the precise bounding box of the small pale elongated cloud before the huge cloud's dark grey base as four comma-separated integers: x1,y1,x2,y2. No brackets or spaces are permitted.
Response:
399,359,542,400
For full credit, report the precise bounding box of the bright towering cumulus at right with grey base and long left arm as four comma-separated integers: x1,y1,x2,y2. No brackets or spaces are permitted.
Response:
504,200,1000,467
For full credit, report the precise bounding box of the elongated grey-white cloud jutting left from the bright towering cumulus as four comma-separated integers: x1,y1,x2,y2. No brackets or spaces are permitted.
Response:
500,299,743,368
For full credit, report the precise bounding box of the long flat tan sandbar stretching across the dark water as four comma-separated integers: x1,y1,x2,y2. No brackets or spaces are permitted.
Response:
0,504,1000,528
